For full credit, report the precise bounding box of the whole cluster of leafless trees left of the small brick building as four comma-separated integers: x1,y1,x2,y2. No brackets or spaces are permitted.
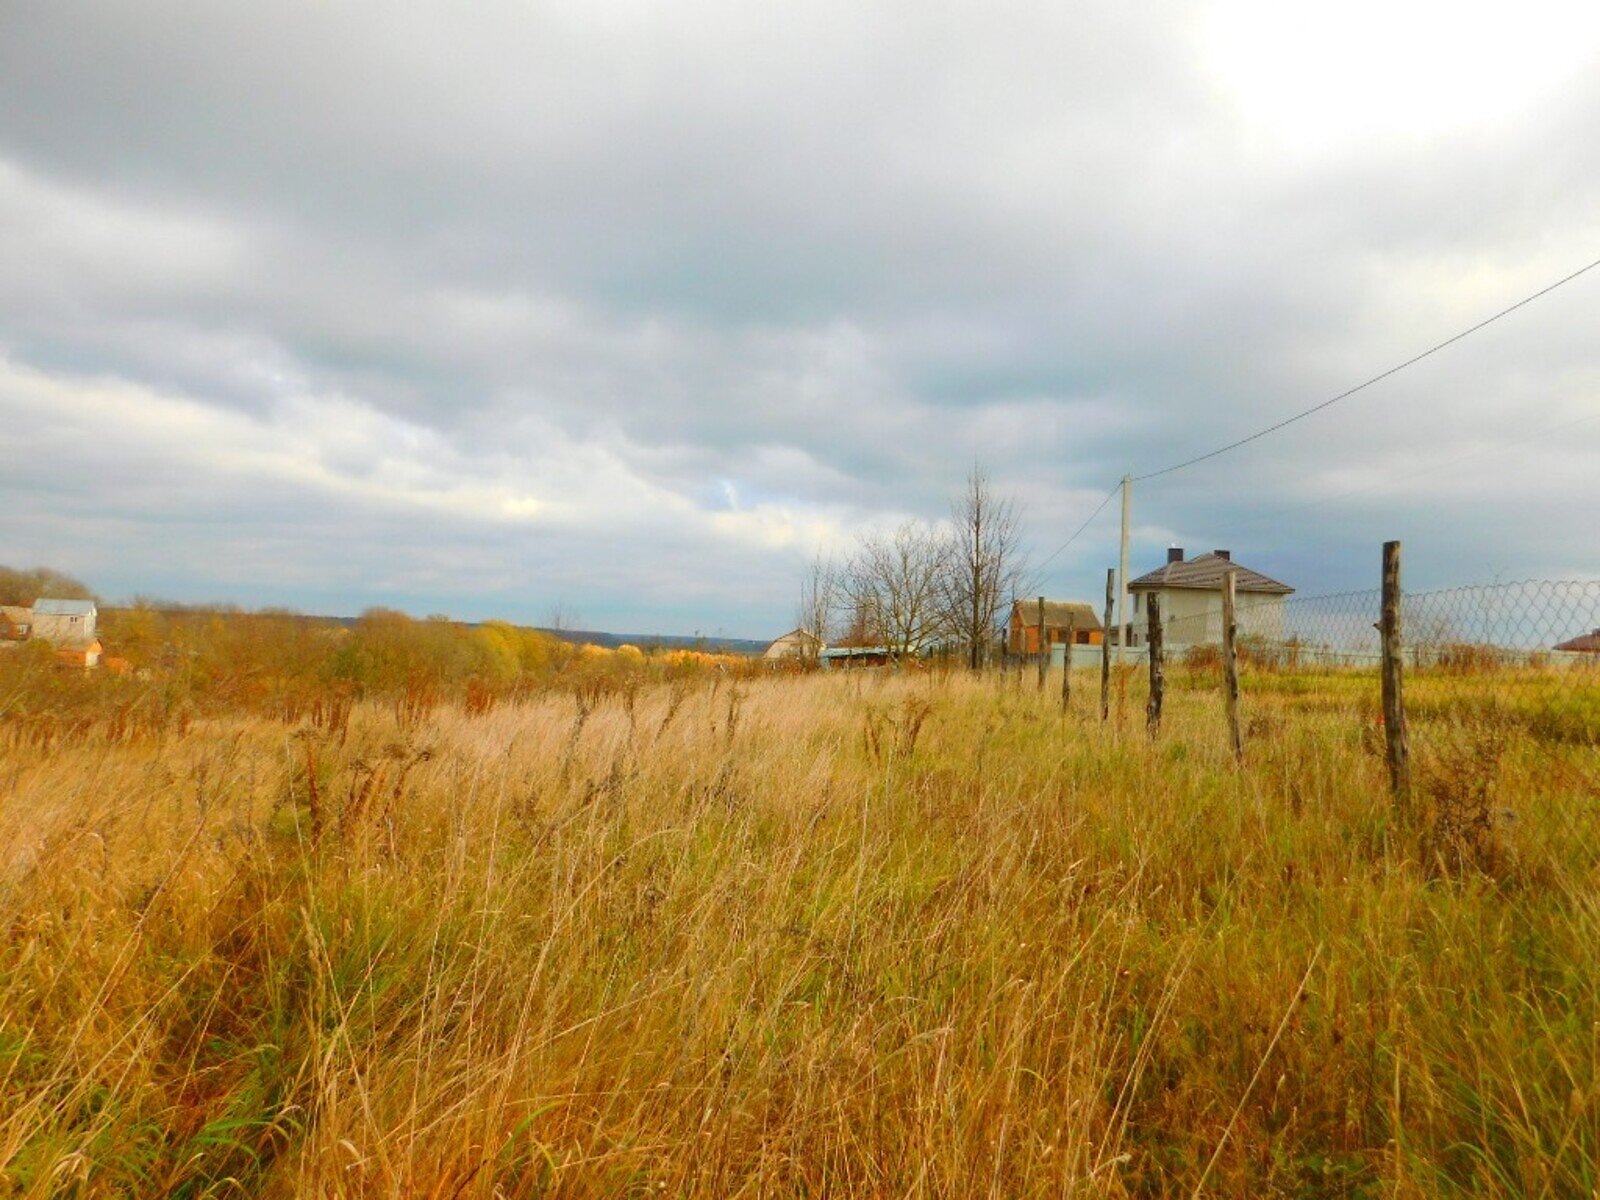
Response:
797,467,1032,669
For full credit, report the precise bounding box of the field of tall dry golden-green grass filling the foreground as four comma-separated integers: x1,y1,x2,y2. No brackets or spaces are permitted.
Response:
0,672,1600,1197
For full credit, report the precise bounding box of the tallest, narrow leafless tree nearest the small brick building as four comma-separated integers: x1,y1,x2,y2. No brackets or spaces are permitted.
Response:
944,466,1029,670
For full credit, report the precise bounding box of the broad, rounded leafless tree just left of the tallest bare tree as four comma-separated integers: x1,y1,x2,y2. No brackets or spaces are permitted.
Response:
843,520,950,656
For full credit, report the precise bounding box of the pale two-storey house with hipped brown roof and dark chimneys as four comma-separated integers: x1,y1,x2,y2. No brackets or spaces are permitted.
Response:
1128,547,1294,646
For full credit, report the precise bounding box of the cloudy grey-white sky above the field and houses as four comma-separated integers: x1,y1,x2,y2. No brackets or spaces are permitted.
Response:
0,0,1600,637
